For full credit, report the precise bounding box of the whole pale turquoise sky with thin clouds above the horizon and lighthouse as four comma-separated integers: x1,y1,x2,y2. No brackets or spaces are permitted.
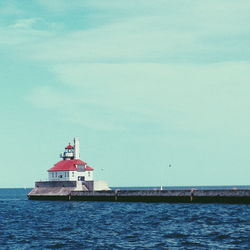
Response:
0,0,250,188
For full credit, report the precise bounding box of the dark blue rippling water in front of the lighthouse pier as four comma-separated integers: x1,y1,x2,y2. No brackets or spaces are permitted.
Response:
0,188,250,250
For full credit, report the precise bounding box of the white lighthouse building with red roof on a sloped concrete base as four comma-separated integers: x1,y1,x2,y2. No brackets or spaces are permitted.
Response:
28,138,110,199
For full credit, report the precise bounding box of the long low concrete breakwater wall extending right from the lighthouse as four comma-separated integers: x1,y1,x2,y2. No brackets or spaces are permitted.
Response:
28,187,250,204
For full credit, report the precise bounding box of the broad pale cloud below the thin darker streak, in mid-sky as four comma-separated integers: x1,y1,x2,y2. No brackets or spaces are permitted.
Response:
28,63,250,133
